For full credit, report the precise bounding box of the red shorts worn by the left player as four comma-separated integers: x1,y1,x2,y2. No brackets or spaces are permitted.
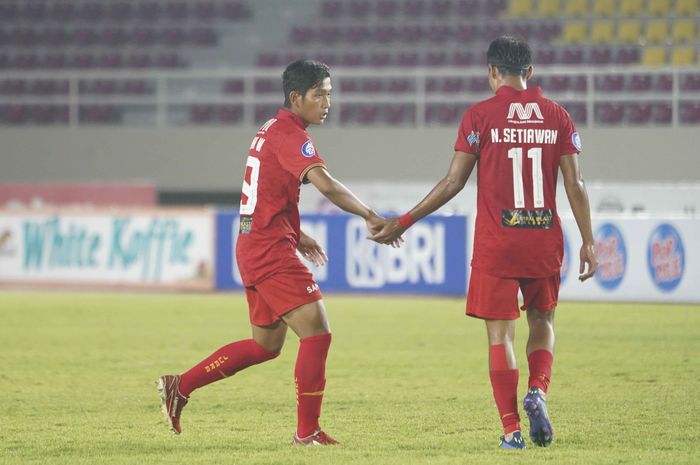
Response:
245,262,323,326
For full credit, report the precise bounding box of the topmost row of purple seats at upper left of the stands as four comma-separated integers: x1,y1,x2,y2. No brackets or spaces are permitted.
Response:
0,0,252,24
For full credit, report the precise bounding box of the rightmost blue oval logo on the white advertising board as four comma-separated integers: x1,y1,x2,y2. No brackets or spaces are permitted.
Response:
647,224,685,292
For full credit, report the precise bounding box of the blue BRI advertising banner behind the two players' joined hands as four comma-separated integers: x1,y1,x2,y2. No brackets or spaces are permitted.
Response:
216,211,469,295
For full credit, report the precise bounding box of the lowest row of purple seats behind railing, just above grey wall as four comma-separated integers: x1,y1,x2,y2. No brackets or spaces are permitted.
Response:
0,101,700,126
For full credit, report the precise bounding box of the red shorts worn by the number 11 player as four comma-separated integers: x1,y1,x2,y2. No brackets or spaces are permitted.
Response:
467,268,561,320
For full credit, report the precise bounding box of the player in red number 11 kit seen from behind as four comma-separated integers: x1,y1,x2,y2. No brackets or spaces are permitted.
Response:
371,37,597,449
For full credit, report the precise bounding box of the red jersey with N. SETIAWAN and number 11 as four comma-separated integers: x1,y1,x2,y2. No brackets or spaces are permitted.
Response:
455,86,581,278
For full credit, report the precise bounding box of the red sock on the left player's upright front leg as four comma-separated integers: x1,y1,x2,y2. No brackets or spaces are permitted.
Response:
294,333,331,438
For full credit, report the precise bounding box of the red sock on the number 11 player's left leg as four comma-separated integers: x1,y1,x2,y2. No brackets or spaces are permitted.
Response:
489,344,520,434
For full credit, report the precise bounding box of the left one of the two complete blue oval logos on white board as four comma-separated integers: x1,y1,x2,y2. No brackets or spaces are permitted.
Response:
595,223,627,291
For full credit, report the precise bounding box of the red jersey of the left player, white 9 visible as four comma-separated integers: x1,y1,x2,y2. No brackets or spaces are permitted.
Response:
236,108,325,286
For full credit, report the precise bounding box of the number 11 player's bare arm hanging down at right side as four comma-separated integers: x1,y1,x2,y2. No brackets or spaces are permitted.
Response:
559,154,598,281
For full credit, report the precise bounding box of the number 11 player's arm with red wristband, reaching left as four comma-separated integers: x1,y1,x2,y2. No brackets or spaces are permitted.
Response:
370,152,477,244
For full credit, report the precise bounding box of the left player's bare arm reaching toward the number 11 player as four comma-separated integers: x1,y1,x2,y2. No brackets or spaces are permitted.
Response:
306,166,403,247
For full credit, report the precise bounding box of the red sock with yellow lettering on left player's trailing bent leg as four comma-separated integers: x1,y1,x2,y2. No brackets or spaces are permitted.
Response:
180,339,279,397
